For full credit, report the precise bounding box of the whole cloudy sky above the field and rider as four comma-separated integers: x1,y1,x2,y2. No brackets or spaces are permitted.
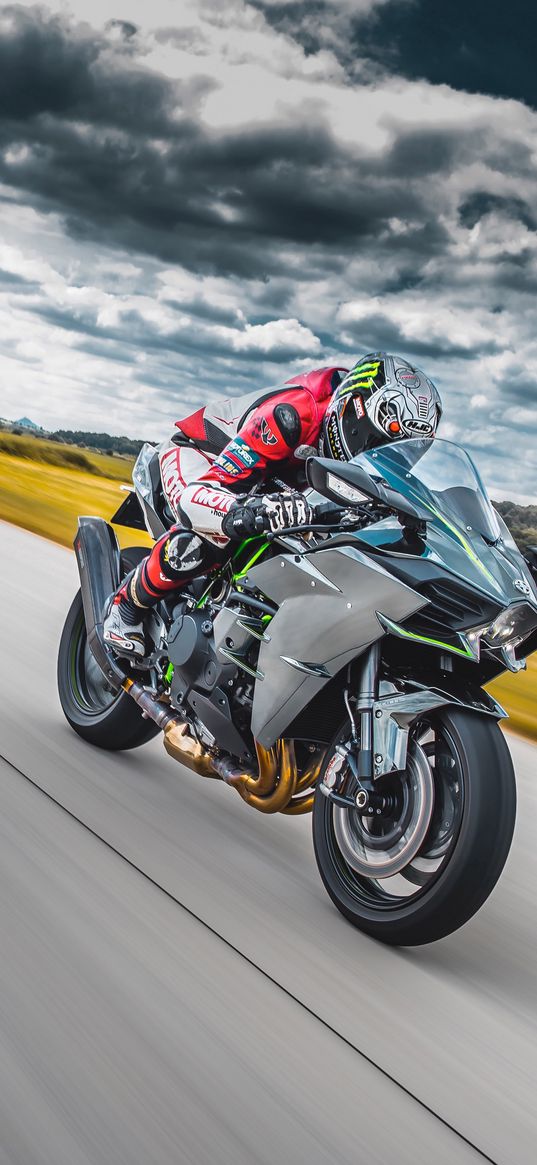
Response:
0,0,537,501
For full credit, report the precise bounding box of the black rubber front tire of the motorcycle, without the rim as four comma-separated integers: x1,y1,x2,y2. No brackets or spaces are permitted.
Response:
313,708,516,946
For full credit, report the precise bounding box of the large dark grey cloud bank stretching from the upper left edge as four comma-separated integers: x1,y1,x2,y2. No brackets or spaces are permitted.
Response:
0,8,480,276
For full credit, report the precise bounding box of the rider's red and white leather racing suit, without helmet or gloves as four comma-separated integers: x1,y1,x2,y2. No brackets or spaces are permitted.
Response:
134,368,347,606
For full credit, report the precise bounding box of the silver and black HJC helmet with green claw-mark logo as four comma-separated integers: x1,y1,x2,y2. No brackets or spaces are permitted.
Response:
322,352,441,461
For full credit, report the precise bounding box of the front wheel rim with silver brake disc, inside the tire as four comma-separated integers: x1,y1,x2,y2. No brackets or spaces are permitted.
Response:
327,721,465,911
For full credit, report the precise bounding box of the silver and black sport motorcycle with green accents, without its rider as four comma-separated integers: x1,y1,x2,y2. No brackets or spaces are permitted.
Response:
58,438,537,946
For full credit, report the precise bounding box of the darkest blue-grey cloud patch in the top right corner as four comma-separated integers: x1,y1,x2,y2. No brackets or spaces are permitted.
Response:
250,0,537,106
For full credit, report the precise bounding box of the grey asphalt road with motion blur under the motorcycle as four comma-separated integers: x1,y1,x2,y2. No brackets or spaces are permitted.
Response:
0,524,537,1165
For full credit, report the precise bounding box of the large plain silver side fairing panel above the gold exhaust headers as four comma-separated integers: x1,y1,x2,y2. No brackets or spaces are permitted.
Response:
248,545,428,748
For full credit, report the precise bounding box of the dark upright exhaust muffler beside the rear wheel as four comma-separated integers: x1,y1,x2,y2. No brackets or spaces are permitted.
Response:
73,517,125,686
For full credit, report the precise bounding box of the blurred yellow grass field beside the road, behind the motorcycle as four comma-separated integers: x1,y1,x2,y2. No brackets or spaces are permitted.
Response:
0,433,537,739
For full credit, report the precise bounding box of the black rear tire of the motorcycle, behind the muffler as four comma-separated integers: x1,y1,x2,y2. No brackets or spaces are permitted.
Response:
57,546,160,751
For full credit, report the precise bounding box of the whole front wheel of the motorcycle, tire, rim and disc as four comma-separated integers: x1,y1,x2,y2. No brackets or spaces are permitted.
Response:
313,708,516,946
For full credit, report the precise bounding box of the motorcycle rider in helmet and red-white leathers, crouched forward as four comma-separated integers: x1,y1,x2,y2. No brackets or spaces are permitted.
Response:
104,352,441,657
